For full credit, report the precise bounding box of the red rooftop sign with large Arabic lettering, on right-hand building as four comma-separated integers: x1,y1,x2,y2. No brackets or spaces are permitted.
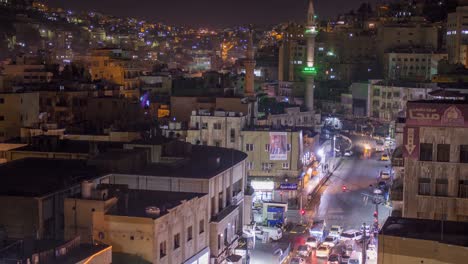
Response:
406,102,468,127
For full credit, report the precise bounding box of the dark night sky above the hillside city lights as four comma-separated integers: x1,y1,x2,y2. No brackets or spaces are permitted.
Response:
45,0,382,27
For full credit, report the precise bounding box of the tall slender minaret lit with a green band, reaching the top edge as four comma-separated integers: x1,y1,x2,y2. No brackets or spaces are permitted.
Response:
303,0,317,111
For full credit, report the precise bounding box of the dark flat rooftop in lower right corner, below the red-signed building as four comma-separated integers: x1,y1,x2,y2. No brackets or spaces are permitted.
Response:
380,216,468,247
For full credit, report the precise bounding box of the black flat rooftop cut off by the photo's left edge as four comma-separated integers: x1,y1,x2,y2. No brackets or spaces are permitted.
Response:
0,158,99,197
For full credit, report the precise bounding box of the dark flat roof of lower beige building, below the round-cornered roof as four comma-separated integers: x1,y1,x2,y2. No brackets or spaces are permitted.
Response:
106,190,206,219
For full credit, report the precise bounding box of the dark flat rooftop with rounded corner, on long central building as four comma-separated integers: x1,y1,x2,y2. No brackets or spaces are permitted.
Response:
136,145,247,179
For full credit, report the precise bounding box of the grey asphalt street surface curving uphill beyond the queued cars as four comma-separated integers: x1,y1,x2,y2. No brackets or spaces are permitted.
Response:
288,154,391,263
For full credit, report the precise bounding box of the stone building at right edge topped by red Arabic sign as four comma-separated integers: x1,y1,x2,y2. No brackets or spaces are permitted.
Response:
403,100,468,221
